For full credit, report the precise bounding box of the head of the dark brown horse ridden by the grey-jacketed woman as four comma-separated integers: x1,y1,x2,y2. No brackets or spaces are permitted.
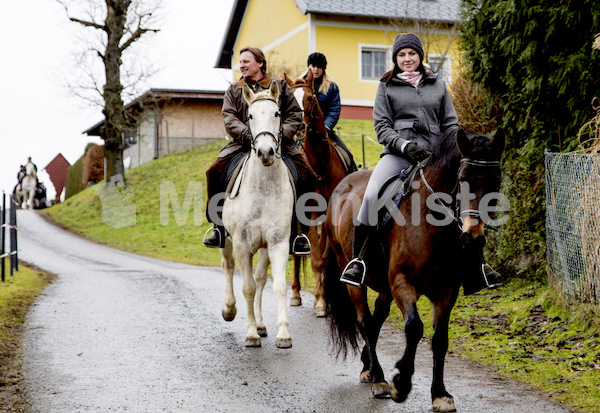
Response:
456,129,505,248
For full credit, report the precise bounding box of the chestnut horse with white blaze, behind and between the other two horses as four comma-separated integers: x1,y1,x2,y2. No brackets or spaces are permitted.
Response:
284,70,348,317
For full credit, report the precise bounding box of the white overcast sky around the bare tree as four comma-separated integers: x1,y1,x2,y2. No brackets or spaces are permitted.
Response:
0,0,233,199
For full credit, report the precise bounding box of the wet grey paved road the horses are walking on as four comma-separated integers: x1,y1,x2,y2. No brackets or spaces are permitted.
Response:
18,211,571,413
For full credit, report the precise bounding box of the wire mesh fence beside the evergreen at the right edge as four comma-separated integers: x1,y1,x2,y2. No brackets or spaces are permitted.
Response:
545,151,600,304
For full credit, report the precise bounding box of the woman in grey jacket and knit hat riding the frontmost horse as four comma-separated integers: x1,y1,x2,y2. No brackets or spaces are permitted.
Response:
341,33,459,285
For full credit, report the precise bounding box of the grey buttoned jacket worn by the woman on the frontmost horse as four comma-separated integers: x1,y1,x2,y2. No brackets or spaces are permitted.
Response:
373,68,459,156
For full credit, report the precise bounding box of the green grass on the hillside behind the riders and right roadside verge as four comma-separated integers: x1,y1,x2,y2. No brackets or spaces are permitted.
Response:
45,120,600,412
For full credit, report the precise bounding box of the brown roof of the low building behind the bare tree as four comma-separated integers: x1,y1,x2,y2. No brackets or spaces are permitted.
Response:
82,89,225,136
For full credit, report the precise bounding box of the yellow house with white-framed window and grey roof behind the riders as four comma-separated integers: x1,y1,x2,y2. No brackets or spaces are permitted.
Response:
215,0,461,119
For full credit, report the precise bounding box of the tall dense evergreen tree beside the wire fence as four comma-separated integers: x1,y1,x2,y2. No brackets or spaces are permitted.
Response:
461,0,600,278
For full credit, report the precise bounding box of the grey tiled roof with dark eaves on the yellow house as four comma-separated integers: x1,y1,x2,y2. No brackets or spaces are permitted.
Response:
215,0,462,69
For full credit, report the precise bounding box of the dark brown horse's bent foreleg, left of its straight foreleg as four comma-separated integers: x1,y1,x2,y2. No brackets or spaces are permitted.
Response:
391,284,423,402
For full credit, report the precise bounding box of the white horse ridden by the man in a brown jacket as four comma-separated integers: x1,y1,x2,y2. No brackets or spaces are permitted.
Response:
220,82,294,348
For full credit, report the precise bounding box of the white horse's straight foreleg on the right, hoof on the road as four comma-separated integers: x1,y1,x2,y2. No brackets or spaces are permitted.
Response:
269,241,292,348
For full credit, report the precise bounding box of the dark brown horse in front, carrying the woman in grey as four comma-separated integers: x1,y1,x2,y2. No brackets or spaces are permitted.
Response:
323,130,504,411
